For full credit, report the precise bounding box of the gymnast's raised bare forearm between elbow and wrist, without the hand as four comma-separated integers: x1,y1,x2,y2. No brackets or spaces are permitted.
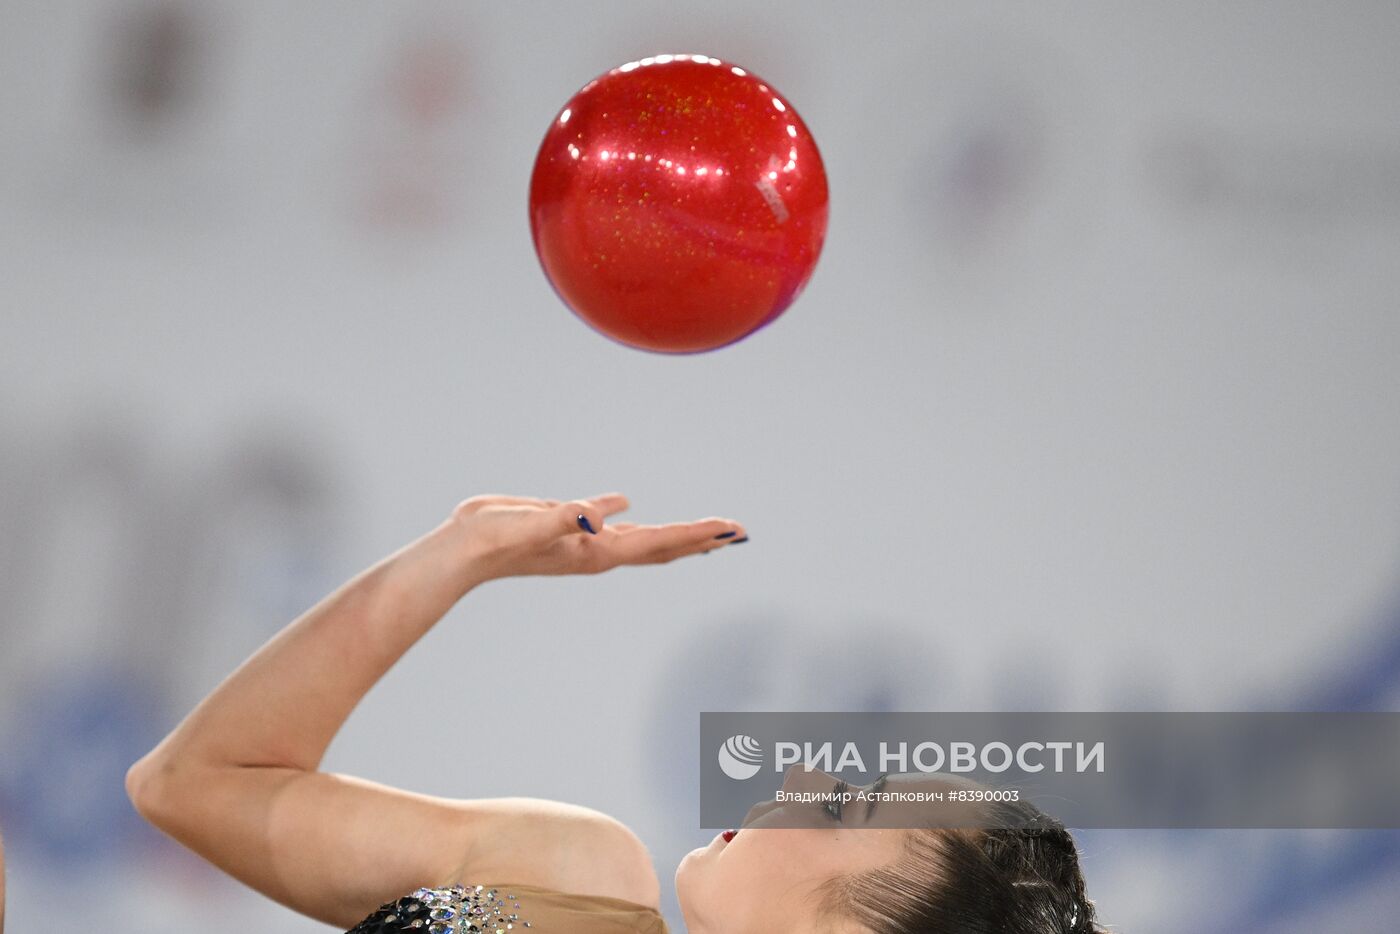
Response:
133,521,479,781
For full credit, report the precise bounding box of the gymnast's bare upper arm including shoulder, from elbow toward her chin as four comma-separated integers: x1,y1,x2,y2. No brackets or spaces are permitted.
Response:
132,767,658,928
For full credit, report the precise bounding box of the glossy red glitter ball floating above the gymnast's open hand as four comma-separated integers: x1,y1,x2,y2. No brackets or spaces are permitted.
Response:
529,55,827,353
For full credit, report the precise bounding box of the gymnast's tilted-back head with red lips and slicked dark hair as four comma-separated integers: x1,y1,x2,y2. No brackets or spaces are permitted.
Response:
676,770,1102,934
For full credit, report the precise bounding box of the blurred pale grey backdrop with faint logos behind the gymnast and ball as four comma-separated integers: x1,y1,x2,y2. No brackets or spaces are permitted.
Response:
0,0,1400,934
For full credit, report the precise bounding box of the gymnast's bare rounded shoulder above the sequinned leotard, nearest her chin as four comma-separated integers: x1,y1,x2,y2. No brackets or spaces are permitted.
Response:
445,798,661,909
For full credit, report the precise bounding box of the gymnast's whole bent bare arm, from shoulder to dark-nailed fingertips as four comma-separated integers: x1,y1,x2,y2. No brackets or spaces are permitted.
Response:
126,494,743,927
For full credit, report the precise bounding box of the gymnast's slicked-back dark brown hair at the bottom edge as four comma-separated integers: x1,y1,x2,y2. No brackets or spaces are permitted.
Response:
826,802,1102,934
